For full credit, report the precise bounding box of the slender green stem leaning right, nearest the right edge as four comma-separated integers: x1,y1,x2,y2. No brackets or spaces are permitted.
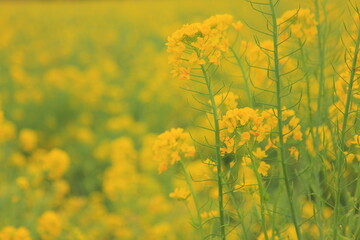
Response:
333,20,360,240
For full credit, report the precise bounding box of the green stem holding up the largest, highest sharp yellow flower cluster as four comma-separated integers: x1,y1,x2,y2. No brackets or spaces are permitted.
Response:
201,65,226,240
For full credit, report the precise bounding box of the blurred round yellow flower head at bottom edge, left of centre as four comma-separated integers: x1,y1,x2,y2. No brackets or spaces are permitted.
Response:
37,211,62,240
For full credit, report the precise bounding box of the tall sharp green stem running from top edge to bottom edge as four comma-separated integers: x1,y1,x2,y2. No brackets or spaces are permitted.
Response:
269,0,301,240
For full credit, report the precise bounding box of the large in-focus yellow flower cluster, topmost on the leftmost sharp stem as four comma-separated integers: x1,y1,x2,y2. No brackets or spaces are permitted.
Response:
166,14,241,79
